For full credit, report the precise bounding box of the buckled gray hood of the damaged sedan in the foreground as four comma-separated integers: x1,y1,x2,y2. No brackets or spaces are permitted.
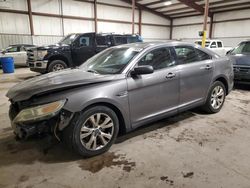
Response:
6,69,119,102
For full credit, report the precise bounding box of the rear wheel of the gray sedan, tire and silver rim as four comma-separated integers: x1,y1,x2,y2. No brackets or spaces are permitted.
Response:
203,81,226,114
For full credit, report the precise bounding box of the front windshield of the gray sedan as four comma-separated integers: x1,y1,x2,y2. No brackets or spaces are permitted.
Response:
80,47,139,74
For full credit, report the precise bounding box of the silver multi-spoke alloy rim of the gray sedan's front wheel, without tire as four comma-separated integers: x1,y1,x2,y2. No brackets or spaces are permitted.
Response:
80,113,114,151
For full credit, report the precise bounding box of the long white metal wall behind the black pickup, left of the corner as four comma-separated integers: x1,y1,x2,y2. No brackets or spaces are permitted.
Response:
0,0,170,49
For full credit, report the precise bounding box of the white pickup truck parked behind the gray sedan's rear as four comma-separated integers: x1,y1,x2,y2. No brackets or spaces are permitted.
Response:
195,40,232,56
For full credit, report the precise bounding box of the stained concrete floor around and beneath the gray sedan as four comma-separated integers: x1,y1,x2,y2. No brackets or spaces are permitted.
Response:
0,69,250,188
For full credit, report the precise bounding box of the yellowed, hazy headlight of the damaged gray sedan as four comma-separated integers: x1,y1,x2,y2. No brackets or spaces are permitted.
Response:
14,100,66,123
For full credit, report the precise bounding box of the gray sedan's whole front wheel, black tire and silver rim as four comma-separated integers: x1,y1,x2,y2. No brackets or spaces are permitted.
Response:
63,106,119,157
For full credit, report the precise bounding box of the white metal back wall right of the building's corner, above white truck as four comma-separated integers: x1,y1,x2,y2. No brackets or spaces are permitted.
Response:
173,9,250,47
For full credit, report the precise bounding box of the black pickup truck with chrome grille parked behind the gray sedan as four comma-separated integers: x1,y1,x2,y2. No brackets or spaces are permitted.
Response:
27,33,142,73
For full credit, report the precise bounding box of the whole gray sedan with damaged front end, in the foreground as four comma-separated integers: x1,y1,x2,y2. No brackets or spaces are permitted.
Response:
7,42,233,156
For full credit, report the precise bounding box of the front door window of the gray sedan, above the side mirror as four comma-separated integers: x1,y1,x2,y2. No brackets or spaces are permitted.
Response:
138,48,174,70
